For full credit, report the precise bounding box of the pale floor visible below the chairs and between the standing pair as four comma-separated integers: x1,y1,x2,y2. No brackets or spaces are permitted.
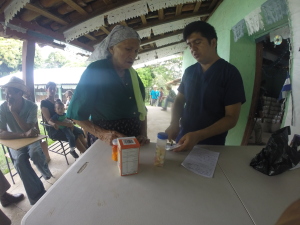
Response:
0,106,171,225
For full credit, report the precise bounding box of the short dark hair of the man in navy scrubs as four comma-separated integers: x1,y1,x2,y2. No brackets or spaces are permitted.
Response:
183,21,218,44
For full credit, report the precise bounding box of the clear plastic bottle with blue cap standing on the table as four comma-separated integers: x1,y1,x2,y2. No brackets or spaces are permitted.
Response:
154,132,168,166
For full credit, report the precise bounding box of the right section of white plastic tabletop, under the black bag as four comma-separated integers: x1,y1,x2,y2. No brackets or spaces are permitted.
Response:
205,146,300,225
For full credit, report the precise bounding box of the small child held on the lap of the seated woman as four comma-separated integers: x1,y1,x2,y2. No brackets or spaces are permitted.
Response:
50,99,79,159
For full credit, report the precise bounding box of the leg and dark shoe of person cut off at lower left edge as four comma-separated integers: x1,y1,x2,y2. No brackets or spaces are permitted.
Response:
0,170,24,225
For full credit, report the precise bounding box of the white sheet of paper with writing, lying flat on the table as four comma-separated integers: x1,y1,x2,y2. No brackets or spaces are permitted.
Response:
181,146,220,178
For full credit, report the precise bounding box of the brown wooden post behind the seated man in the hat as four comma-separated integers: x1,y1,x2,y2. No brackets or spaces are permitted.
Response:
22,41,35,102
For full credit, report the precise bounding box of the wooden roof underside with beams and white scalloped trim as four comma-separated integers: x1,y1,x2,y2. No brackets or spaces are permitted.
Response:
0,0,222,61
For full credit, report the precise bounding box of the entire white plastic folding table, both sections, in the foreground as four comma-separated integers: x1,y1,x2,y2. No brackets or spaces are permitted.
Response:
22,141,300,225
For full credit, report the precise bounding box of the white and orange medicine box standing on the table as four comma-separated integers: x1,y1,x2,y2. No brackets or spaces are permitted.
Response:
118,137,140,176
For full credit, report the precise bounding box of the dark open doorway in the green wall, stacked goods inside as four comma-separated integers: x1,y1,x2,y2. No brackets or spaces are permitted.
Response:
242,31,290,145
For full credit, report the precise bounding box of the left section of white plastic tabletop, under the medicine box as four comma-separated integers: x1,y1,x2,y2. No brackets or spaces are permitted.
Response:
22,140,253,225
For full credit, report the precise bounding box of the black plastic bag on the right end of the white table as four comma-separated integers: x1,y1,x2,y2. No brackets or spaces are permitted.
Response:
250,126,300,176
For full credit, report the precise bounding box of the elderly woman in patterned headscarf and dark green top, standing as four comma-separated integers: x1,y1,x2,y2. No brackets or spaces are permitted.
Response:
67,25,149,145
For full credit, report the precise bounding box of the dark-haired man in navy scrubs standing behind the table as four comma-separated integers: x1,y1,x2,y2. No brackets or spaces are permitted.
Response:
166,21,246,151
